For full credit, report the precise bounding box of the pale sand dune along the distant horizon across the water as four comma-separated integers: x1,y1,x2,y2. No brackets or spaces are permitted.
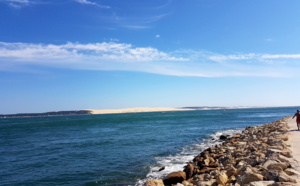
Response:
88,107,195,114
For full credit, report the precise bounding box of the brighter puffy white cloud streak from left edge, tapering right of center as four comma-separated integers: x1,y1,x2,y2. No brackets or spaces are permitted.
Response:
0,42,185,62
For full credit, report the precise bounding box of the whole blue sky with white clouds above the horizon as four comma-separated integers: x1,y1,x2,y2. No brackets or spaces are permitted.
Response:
0,0,300,114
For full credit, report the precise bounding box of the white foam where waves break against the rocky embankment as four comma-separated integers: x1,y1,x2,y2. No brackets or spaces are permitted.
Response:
135,129,242,186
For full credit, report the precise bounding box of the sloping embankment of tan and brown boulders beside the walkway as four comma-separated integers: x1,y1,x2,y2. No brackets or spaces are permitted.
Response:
144,117,300,186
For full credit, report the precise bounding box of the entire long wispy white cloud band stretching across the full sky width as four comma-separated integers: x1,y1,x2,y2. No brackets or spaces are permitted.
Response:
0,42,300,77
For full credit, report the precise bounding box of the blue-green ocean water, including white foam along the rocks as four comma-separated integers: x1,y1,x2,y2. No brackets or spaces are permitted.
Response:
0,107,297,186
